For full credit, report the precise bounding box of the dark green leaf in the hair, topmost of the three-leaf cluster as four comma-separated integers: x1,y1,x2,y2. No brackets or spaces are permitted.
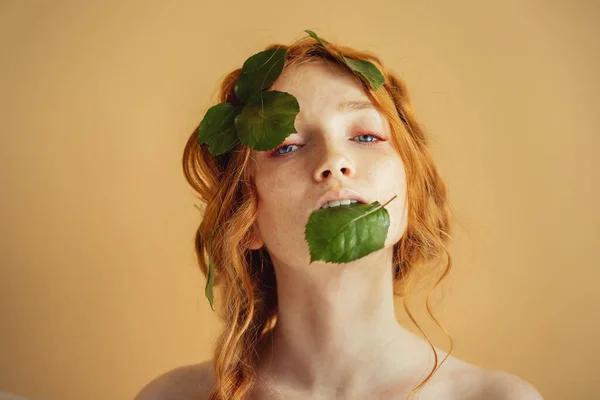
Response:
233,49,287,104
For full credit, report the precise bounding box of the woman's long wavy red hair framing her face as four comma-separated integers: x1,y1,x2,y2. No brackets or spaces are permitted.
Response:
183,32,453,400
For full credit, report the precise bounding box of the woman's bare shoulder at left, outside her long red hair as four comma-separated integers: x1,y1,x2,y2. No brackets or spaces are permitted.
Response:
133,361,216,400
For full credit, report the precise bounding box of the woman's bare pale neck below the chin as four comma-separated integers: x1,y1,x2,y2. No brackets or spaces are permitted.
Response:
259,249,424,398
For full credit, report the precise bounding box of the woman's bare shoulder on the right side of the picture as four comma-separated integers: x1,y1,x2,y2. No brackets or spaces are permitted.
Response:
455,366,543,400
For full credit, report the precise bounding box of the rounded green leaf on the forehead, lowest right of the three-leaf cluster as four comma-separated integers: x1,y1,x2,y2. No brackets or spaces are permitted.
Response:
235,90,300,151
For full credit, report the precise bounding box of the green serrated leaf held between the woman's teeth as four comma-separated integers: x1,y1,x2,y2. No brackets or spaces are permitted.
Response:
304,196,396,263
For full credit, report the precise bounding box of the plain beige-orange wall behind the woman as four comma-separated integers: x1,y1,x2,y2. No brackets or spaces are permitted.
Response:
0,0,600,400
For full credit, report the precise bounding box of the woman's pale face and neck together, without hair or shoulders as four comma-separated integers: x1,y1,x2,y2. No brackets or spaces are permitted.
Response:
244,57,430,398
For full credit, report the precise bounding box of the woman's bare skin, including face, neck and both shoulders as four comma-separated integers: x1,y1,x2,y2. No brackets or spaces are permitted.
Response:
135,57,543,400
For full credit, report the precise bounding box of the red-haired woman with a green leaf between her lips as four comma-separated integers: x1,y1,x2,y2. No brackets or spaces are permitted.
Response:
136,31,541,400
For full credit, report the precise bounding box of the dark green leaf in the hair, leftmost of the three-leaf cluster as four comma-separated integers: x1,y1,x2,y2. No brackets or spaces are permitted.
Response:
198,103,241,156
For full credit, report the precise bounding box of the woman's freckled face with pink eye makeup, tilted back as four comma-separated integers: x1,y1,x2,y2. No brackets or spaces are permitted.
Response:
251,61,407,268
